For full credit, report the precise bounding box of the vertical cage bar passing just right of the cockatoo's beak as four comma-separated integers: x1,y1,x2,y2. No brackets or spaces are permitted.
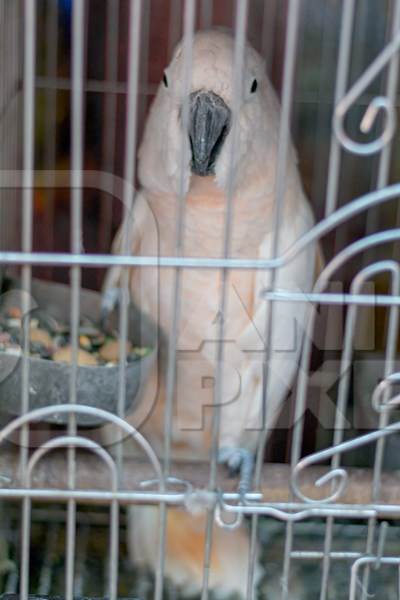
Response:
201,0,249,600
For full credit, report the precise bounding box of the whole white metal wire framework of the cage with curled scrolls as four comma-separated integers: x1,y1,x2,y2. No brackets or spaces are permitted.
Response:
0,0,400,600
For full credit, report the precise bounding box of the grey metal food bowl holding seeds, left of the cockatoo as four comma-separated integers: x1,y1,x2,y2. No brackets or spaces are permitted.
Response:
0,280,158,427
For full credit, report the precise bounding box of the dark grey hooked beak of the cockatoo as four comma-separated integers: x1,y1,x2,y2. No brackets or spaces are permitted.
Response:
189,91,231,176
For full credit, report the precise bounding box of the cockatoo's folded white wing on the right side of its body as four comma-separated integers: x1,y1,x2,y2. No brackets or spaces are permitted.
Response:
220,188,317,450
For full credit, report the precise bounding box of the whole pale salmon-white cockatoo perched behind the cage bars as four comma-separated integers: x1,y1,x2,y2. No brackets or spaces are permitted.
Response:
104,30,317,598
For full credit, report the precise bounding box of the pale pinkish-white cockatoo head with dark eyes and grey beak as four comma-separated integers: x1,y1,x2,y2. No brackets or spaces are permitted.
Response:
139,30,279,193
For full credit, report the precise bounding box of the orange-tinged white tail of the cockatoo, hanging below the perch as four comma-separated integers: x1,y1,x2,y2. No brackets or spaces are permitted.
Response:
128,506,260,599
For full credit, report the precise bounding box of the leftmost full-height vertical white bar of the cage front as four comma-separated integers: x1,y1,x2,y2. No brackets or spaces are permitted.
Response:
20,0,36,600
